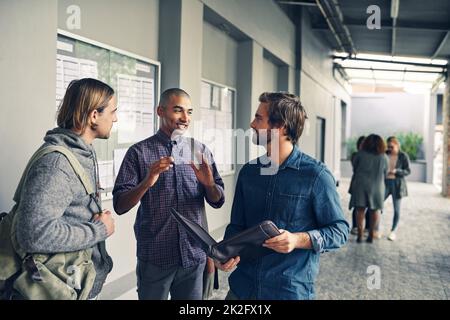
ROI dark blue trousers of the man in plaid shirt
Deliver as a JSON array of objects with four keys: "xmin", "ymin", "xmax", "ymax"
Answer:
[{"xmin": 136, "ymin": 259, "xmax": 205, "ymax": 300}]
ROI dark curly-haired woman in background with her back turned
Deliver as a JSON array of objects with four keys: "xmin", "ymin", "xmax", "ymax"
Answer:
[{"xmin": 350, "ymin": 134, "xmax": 388, "ymax": 242}]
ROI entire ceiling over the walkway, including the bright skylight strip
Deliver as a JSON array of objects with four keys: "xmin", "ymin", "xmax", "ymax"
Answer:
[{"xmin": 277, "ymin": 0, "xmax": 450, "ymax": 88}]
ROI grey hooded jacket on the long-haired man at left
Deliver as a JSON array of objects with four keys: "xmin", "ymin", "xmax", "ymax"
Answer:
[{"xmin": 16, "ymin": 128, "xmax": 112, "ymax": 298}]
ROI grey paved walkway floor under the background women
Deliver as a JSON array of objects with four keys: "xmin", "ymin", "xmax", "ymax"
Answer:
[{"xmin": 213, "ymin": 180, "xmax": 450, "ymax": 300}]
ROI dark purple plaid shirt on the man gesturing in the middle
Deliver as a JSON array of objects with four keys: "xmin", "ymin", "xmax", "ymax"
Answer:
[{"xmin": 113, "ymin": 130, "xmax": 225, "ymax": 268}]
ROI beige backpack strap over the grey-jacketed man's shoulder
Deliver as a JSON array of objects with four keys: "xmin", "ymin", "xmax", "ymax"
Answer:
[{"xmin": 13, "ymin": 145, "xmax": 95, "ymax": 203}]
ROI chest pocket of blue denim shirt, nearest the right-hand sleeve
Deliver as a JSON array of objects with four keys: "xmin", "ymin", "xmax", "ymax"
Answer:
[{"xmin": 275, "ymin": 192, "xmax": 310, "ymax": 231}]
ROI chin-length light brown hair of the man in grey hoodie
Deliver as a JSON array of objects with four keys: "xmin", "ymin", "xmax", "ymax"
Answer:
[{"xmin": 57, "ymin": 78, "xmax": 114, "ymax": 133}]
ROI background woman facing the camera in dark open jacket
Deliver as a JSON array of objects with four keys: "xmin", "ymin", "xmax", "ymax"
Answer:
[{"xmin": 385, "ymin": 137, "xmax": 411, "ymax": 241}]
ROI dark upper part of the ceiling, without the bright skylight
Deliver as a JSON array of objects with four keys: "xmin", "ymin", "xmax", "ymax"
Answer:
[{"xmin": 277, "ymin": 0, "xmax": 450, "ymax": 59}]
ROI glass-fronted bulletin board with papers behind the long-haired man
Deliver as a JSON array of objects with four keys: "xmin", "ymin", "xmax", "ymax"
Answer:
[{"xmin": 56, "ymin": 30, "xmax": 161, "ymax": 197}]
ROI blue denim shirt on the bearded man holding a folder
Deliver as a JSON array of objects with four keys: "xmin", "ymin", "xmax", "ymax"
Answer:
[{"xmin": 224, "ymin": 147, "xmax": 349, "ymax": 300}]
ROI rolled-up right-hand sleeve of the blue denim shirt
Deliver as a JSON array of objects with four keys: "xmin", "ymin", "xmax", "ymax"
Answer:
[{"xmin": 307, "ymin": 168, "xmax": 349, "ymax": 253}]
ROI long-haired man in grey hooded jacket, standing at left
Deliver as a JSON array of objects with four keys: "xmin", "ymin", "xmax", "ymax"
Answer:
[{"xmin": 16, "ymin": 79, "xmax": 117, "ymax": 299}]
